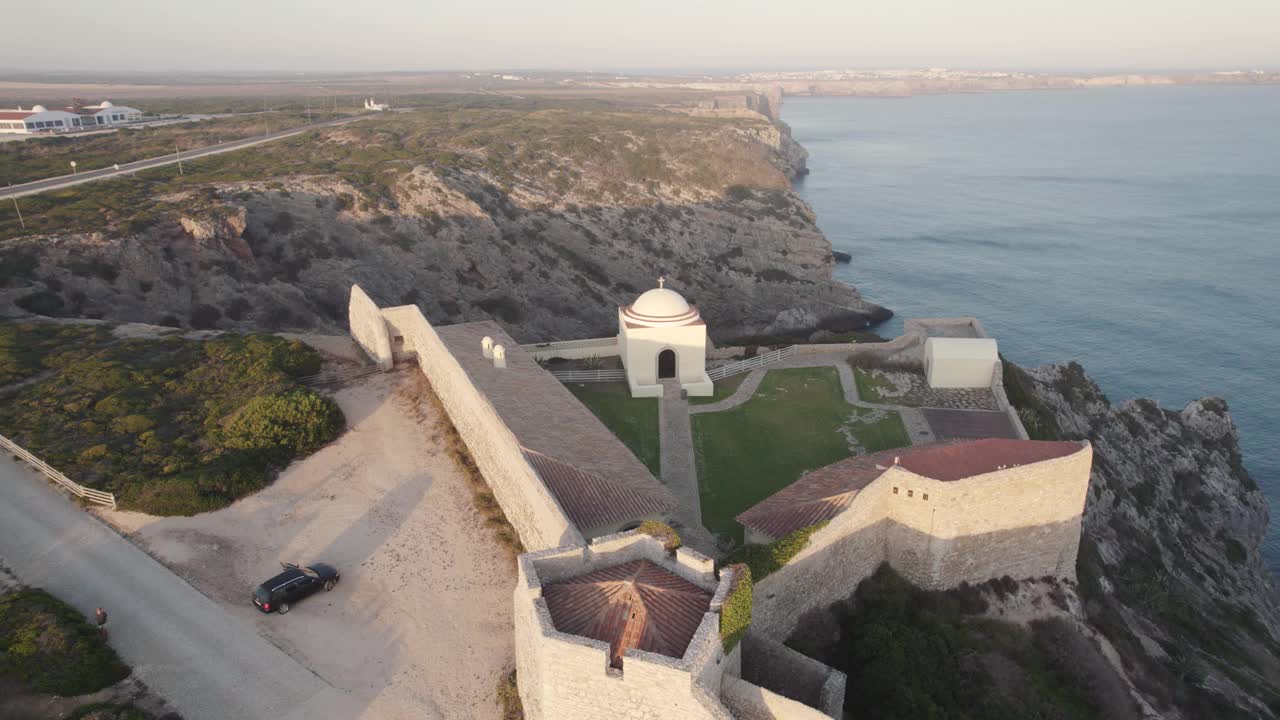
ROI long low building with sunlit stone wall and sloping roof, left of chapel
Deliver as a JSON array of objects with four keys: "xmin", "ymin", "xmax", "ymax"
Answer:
[{"xmin": 351, "ymin": 287, "xmax": 676, "ymax": 550}]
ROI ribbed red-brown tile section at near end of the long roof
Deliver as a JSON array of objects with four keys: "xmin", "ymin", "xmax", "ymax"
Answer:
[{"xmin": 521, "ymin": 447, "xmax": 676, "ymax": 529}]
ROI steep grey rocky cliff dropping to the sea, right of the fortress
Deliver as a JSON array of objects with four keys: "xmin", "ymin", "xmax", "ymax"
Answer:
[{"xmin": 1015, "ymin": 364, "xmax": 1280, "ymax": 719}]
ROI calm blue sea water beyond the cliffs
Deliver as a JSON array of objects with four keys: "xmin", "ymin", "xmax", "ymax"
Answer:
[{"xmin": 783, "ymin": 87, "xmax": 1280, "ymax": 570}]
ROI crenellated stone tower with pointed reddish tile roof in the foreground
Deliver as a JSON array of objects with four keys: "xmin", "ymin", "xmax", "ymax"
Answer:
[{"xmin": 513, "ymin": 532, "xmax": 845, "ymax": 720}]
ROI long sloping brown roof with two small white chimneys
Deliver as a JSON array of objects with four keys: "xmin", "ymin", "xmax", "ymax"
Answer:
[{"xmin": 435, "ymin": 320, "xmax": 676, "ymax": 530}]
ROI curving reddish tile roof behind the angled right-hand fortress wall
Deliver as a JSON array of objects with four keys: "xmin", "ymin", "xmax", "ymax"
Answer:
[{"xmin": 737, "ymin": 430, "xmax": 1082, "ymax": 538}]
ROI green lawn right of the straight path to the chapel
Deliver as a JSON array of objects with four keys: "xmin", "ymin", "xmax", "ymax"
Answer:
[{"xmin": 692, "ymin": 368, "xmax": 910, "ymax": 542}]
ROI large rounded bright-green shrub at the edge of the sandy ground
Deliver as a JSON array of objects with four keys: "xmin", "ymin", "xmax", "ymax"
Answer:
[{"xmin": 227, "ymin": 389, "xmax": 343, "ymax": 455}]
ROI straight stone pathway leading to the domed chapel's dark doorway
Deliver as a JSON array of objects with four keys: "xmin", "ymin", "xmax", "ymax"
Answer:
[{"xmin": 658, "ymin": 379, "xmax": 721, "ymax": 557}]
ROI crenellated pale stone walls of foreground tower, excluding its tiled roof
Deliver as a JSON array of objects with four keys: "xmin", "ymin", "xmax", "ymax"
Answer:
[{"xmin": 513, "ymin": 532, "xmax": 845, "ymax": 720}]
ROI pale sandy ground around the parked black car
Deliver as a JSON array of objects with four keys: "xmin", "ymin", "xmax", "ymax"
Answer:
[{"xmin": 102, "ymin": 370, "xmax": 515, "ymax": 719}]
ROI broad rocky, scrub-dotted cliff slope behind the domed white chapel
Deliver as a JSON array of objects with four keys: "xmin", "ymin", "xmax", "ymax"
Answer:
[{"xmin": 0, "ymin": 105, "xmax": 888, "ymax": 341}]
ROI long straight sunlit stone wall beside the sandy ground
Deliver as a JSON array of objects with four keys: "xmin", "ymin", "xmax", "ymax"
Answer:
[{"xmin": 349, "ymin": 286, "xmax": 584, "ymax": 550}]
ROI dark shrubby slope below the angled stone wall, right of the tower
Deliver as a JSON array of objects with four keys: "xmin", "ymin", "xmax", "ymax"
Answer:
[{"xmin": 788, "ymin": 565, "xmax": 1139, "ymax": 720}]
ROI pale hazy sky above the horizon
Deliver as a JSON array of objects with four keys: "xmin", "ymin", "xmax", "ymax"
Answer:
[{"xmin": 0, "ymin": 0, "xmax": 1280, "ymax": 72}]
